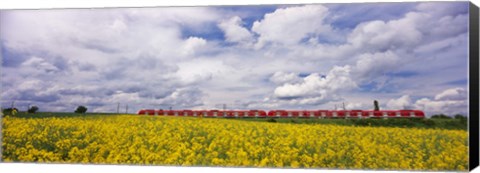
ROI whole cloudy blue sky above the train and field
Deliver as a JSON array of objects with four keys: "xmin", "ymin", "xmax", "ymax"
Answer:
[{"xmin": 0, "ymin": 2, "xmax": 468, "ymax": 115}]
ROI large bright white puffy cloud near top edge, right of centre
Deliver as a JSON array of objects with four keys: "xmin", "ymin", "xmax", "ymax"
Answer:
[{"xmin": 252, "ymin": 5, "xmax": 331, "ymax": 48}]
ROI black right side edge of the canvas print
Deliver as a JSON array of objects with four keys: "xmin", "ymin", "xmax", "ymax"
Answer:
[{"xmin": 468, "ymin": 2, "xmax": 480, "ymax": 171}]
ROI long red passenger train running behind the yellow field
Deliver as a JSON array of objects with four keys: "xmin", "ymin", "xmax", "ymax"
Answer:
[{"xmin": 138, "ymin": 109, "xmax": 425, "ymax": 118}]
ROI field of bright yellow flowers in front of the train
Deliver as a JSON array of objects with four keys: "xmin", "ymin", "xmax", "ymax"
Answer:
[{"xmin": 2, "ymin": 115, "xmax": 468, "ymax": 171}]
